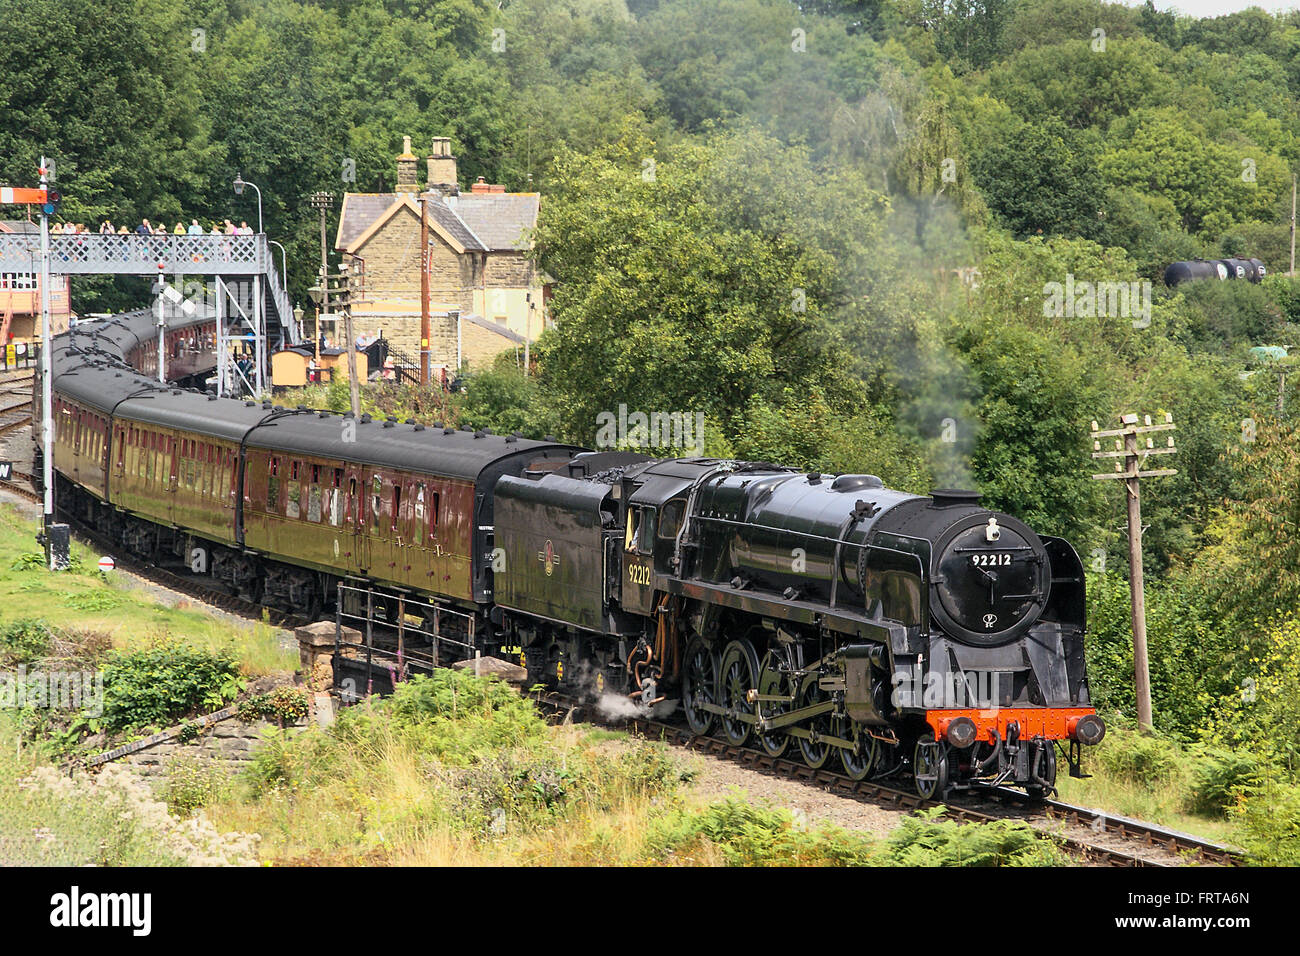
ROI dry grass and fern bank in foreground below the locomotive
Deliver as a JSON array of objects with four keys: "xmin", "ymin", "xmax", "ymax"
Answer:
[{"xmin": 187, "ymin": 671, "xmax": 1066, "ymax": 866}]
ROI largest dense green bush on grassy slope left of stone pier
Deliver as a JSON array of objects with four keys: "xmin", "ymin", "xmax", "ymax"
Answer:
[{"xmin": 96, "ymin": 644, "xmax": 243, "ymax": 734}]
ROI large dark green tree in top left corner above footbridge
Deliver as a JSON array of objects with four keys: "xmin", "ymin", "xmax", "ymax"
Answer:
[{"xmin": 0, "ymin": 0, "xmax": 218, "ymax": 222}]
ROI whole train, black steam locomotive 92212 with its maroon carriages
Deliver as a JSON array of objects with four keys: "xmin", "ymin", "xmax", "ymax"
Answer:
[{"xmin": 35, "ymin": 312, "xmax": 1105, "ymax": 797}]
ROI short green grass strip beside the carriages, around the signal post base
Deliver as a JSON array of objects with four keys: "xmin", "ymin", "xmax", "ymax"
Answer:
[{"xmin": 0, "ymin": 503, "xmax": 298, "ymax": 676}]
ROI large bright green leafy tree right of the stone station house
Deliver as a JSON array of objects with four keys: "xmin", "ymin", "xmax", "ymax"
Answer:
[{"xmin": 527, "ymin": 130, "xmax": 884, "ymax": 450}]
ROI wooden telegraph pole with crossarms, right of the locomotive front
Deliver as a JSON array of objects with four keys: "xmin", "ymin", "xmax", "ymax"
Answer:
[{"xmin": 1092, "ymin": 412, "xmax": 1178, "ymax": 730}]
